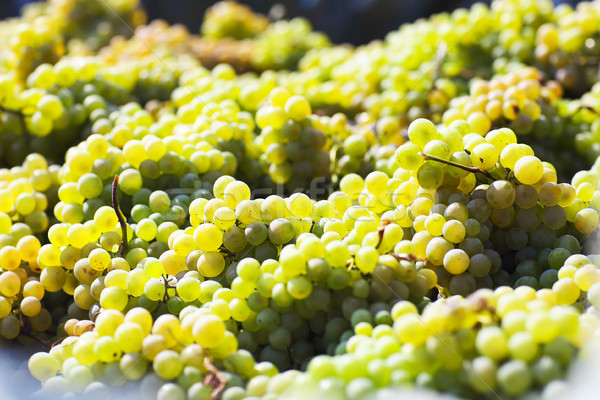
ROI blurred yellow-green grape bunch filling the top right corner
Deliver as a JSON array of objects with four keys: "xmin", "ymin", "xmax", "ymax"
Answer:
[{"xmin": 434, "ymin": 0, "xmax": 600, "ymax": 96}]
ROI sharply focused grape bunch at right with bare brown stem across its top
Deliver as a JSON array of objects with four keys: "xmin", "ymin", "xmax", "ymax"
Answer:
[{"xmin": 394, "ymin": 120, "xmax": 598, "ymax": 295}]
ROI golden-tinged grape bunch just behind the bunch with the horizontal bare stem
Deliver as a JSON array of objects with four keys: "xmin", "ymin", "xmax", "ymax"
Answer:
[{"xmin": 443, "ymin": 67, "xmax": 586, "ymax": 181}]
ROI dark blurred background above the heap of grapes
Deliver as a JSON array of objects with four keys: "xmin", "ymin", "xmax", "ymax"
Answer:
[{"xmin": 0, "ymin": 0, "xmax": 579, "ymax": 44}]
